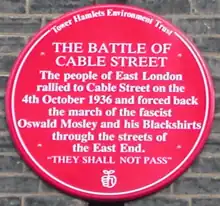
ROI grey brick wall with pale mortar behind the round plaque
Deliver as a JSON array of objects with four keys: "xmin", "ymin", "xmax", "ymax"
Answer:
[{"xmin": 0, "ymin": 0, "xmax": 220, "ymax": 206}]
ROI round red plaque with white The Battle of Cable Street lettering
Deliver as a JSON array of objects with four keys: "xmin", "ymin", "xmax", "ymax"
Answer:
[{"xmin": 6, "ymin": 5, "xmax": 214, "ymax": 200}]
